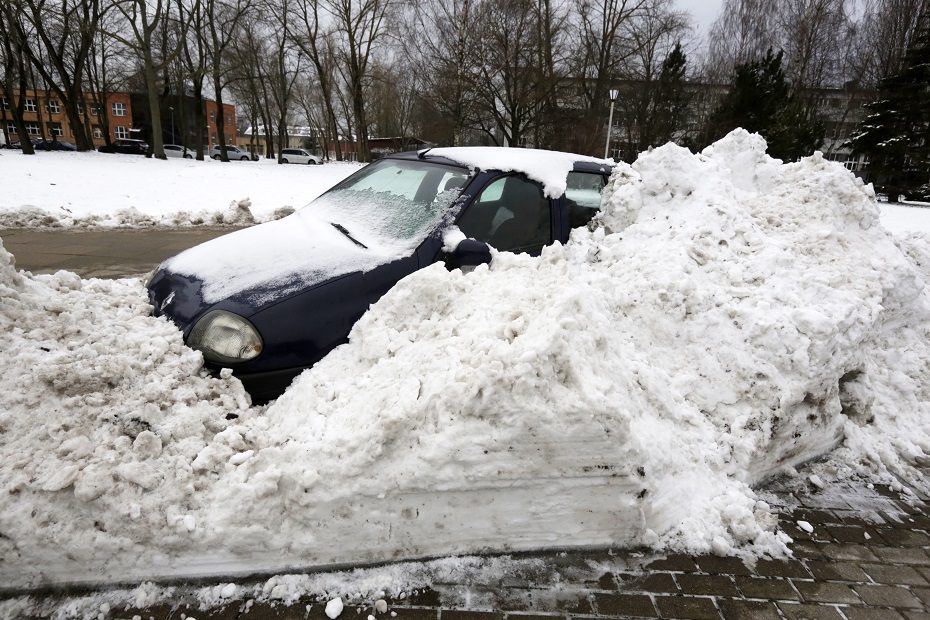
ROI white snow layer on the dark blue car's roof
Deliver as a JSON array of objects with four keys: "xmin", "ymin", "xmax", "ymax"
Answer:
[{"xmin": 420, "ymin": 146, "xmax": 616, "ymax": 198}]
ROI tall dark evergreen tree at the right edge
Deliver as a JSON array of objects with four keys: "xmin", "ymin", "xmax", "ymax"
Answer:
[{"xmin": 847, "ymin": 10, "xmax": 930, "ymax": 202}]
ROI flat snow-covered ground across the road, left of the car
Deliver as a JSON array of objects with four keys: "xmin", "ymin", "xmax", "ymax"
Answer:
[{"xmin": 0, "ymin": 150, "xmax": 359, "ymax": 228}]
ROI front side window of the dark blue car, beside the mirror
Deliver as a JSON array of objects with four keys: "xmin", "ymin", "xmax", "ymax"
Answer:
[{"xmin": 458, "ymin": 175, "xmax": 552, "ymax": 253}]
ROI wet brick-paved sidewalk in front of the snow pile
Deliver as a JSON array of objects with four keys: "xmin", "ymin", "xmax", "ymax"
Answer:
[{"xmin": 7, "ymin": 472, "xmax": 930, "ymax": 620}]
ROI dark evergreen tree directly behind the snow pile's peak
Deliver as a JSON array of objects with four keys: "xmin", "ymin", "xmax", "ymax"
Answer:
[{"xmin": 706, "ymin": 49, "xmax": 824, "ymax": 160}]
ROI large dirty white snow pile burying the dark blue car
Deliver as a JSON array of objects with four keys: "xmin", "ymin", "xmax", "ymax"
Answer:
[{"xmin": 0, "ymin": 131, "xmax": 930, "ymax": 583}]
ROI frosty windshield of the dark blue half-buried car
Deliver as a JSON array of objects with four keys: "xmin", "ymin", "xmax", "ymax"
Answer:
[{"xmin": 301, "ymin": 159, "xmax": 469, "ymax": 246}]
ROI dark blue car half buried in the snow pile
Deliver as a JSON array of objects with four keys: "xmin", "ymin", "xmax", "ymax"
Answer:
[{"xmin": 147, "ymin": 147, "xmax": 611, "ymax": 402}]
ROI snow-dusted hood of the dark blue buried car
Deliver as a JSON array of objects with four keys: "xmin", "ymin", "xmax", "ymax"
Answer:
[{"xmin": 161, "ymin": 209, "xmax": 415, "ymax": 307}]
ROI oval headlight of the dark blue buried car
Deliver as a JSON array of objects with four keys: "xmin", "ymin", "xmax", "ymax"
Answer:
[{"xmin": 187, "ymin": 310, "xmax": 262, "ymax": 364}]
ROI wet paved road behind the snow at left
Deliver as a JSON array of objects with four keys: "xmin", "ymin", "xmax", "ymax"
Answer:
[{"xmin": 0, "ymin": 227, "xmax": 234, "ymax": 278}]
